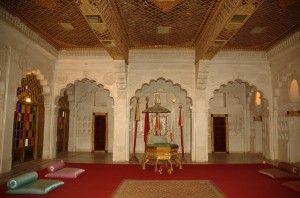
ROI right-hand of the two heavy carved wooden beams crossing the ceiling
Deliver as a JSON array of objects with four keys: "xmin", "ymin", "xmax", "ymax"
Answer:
[{"xmin": 195, "ymin": 0, "xmax": 264, "ymax": 63}]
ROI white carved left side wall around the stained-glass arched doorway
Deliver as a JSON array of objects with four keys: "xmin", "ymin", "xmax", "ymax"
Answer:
[{"xmin": 0, "ymin": 15, "xmax": 56, "ymax": 173}]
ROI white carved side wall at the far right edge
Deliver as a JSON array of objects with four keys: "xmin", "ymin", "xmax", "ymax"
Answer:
[{"xmin": 268, "ymin": 31, "xmax": 300, "ymax": 162}]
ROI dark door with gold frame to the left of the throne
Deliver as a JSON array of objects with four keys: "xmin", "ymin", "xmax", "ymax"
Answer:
[{"xmin": 92, "ymin": 113, "xmax": 108, "ymax": 152}]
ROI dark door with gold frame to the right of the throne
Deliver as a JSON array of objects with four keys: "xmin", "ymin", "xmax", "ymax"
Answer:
[{"xmin": 210, "ymin": 114, "xmax": 229, "ymax": 153}]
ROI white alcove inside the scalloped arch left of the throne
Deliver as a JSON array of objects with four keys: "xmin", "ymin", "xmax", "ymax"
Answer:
[{"xmin": 57, "ymin": 79, "xmax": 114, "ymax": 152}]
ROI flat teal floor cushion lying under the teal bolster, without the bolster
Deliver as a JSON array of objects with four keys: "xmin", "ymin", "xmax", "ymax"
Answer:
[{"xmin": 6, "ymin": 179, "xmax": 64, "ymax": 195}]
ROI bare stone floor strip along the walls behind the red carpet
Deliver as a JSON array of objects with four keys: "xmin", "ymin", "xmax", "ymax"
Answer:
[{"xmin": 0, "ymin": 152, "xmax": 275, "ymax": 184}]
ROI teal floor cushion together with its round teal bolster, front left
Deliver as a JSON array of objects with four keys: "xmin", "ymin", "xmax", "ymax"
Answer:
[{"xmin": 6, "ymin": 171, "xmax": 64, "ymax": 194}]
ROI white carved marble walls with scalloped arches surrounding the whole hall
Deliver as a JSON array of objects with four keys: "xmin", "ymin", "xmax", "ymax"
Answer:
[{"xmin": 0, "ymin": 5, "xmax": 300, "ymax": 173}]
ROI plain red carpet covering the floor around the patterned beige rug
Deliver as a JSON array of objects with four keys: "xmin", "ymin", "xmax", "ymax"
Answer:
[{"xmin": 0, "ymin": 163, "xmax": 300, "ymax": 198}]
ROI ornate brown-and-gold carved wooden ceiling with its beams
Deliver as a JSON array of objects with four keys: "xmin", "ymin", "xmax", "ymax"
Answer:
[{"xmin": 0, "ymin": 0, "xmax": 300, "ymax": 62}]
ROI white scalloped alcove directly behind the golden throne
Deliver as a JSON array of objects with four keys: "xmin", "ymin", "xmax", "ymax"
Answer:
[{"xmin": 130, "ymin": 78, "xmax": 192, "ymax": 156}]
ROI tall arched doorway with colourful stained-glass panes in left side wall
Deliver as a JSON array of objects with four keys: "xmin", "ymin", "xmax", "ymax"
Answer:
[{"xmin": 12, "ymin": 73, "xmax": 45, "ymax": 165}]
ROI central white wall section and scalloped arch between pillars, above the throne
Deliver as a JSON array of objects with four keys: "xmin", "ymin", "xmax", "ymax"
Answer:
[{"xmin": 127, "ymin": 50, "xmax": 195, "ymax": 156}]
